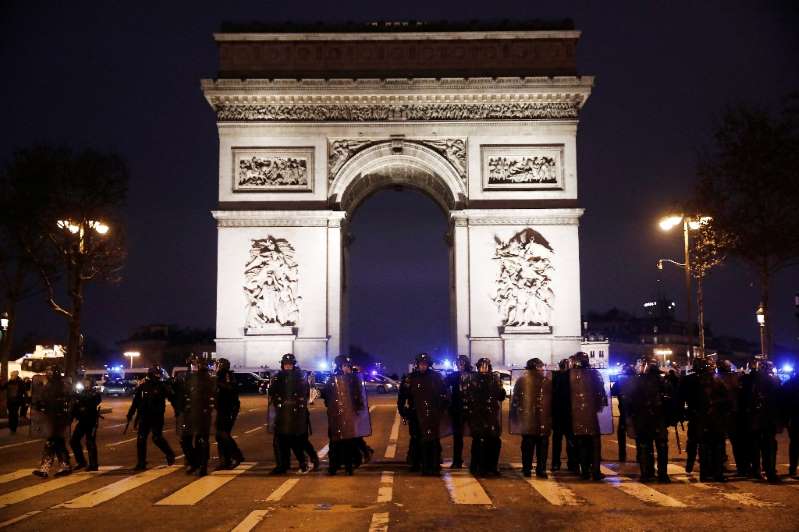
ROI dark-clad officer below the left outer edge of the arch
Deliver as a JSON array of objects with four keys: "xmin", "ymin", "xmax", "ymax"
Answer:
[{"xmin": 216, "ymin": 358, "xmax": 244, "ymax": 469}]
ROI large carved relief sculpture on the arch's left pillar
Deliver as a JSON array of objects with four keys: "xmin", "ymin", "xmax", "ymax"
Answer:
[{"xmin": 244, "ymin": 236, "xmax": 300, "ymax": 329}]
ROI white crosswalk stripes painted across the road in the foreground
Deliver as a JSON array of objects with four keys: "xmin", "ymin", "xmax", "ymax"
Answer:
[{"xmin": 0, "ymin": 460, "xmax": 786, "ymax": 532}]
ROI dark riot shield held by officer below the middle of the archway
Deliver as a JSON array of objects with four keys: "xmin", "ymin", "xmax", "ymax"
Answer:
[{"xmin": 410, "ymin": 370, "xmax": 452, "ymax": 440}]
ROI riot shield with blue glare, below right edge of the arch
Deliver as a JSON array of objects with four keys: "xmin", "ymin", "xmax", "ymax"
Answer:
[{"xmin": 569, "ymin": 368, "xmax": 613, "ymax": 436}]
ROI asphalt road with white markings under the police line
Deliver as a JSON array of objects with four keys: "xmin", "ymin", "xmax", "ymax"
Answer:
[{"xmin": 0, "ymin": 395, "xmax": 799, "ymax": 532}]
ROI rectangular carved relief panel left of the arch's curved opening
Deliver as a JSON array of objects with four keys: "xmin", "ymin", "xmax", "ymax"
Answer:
[{"xmin": 233, "ymin": 147, "xmax": 314, "ymax": 192}]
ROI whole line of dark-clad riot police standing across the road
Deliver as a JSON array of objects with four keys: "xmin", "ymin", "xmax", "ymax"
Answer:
[{"xmin": 5, "ymin": 353, "xmax": 799, "ymax": 482}]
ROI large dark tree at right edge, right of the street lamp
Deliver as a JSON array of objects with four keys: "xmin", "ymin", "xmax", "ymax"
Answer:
[{"xmin": 696, "ymin": 95, "xmax": 799, "ymax": 356}]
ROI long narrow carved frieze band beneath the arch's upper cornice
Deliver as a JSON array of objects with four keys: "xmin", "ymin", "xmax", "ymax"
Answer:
[{"xmin": 216, "ymin": 101, "xmax": 580, "ymax": 122}]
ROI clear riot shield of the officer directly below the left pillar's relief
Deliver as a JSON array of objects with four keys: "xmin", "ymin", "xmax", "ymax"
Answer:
[{"xmin": 266, "ymin": 371, "xmax": 309, "ymax": 435}]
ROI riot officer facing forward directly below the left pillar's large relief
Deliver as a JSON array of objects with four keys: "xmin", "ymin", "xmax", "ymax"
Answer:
[{"xmin": 267, "ymin": 353, "xmax": 310, "ymax": 475}]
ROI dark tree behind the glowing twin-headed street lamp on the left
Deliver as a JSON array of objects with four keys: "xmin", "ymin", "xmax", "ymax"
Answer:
[{"xmin": 7, "ymin": 146, "xmax": 128, "ymax": 375}]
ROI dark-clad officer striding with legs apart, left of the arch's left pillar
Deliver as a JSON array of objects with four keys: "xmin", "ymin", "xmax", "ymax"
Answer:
[{"xmin": 127, "ymin": 364, "xmax": 175, "ymax": 471}]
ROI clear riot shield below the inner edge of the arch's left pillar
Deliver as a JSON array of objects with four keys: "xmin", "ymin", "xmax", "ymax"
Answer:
[{"xmin": 325, "ymin": 374, "xmax": 372, "ymax": 441}]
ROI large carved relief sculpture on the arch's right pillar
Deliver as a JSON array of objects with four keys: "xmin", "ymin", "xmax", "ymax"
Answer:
[{"xmin": 492, "ymin": 228, "xmax": 555, "ymax": 327}]
